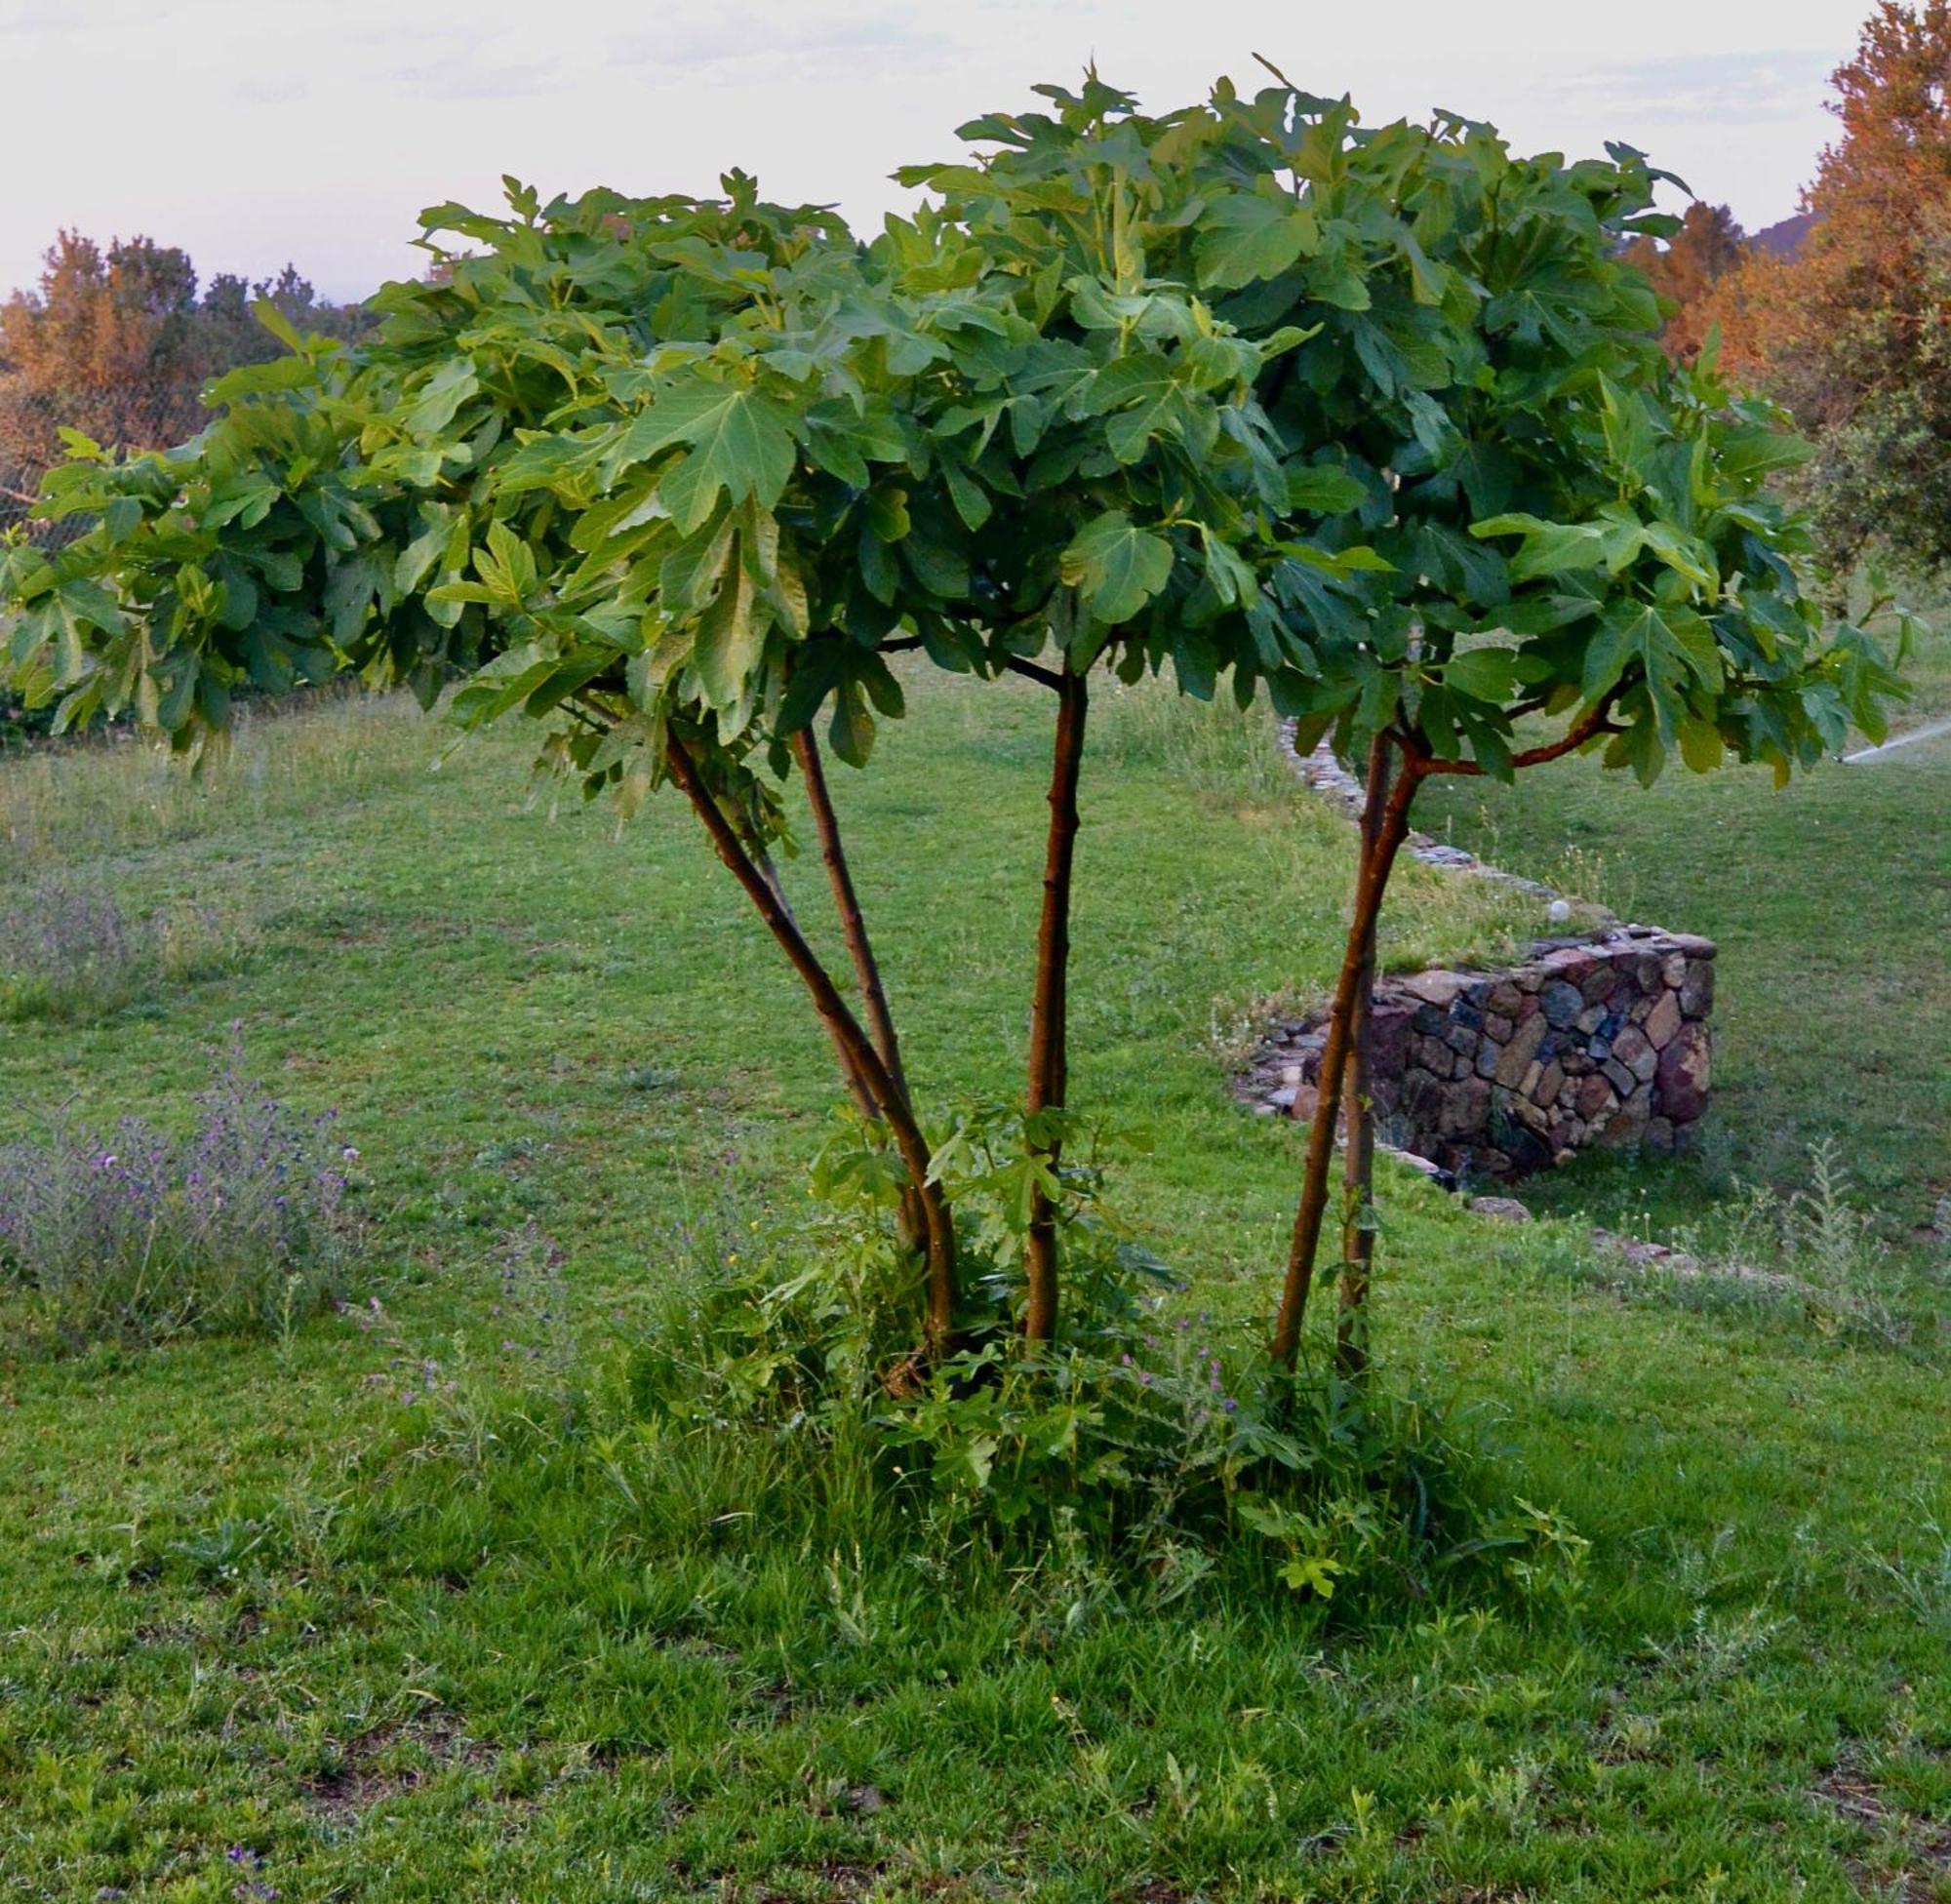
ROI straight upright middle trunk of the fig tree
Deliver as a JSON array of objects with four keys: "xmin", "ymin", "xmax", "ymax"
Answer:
[{"xmin": 1022, "ymin": 673, "xmax": 1089, "ymax": 1342}]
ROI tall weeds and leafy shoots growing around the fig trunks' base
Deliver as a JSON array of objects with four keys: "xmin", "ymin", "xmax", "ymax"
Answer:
[{"xmin": 373, "ymin": 1106, "xmax": 1584, "ymax": 1623}]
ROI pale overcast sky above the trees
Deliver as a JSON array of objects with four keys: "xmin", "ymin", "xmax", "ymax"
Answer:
[{"xmin": 0, "ymin": 0, "xmax": 1869, "ymax": 298}]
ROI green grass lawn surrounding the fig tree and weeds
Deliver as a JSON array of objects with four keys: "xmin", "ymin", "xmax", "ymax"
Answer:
[{"xmin": 0, "ymin": 683, "xmax": 1951, "ymax": 1904}]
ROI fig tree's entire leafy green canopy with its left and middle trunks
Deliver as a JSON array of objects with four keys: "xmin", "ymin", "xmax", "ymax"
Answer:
[{"xmin": 0, "ymin": 74, "xmax": 1892, "ymax": 1344}]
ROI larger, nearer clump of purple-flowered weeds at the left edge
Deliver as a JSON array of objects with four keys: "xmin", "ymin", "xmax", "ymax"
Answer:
[{"xmin": 0, "ymin": 1046, "xmax": 355, "ymax": 1350}]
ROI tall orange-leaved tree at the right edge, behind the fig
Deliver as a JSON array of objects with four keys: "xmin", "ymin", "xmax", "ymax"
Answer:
[{"xmin": 1699, "ymin": 0, "xmax": 1951, "ymax": 568}]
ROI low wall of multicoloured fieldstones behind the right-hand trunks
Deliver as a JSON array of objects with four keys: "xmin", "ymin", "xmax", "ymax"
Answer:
[{"xmin": 1243, "ymin": 925, "xmax": 1715, "ymax": 1176}]
